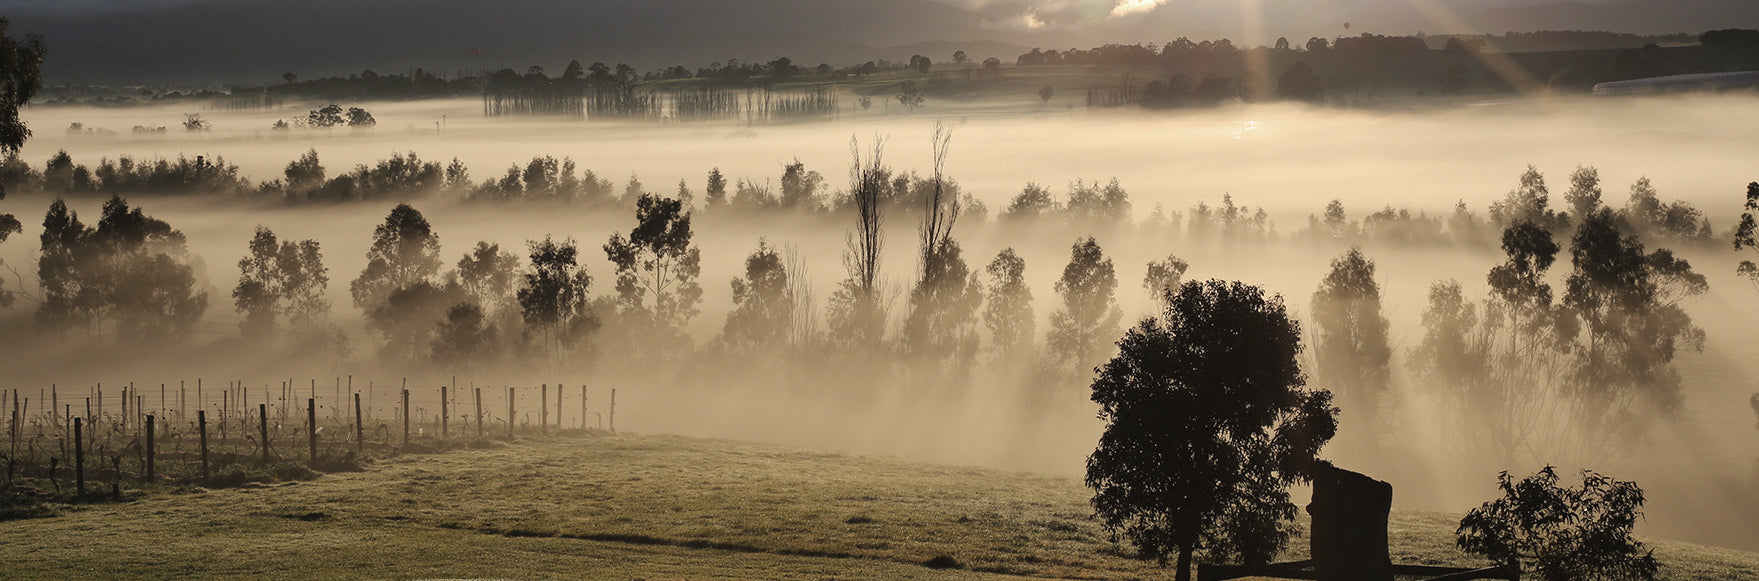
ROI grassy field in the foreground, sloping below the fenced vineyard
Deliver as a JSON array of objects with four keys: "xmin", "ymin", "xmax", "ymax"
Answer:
[{"xmin": 0, "ymin": 435, "xmax": 1759, "ymax": 579}]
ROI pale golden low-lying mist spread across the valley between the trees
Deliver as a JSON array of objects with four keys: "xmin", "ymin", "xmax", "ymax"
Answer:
[{"xmin": 0, "ymin": 95, "xmax": 1759, "ymax": 549}]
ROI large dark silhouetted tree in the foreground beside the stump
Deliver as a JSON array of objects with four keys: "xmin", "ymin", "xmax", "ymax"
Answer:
[{"xmin": 1087, "ymin": 280, "xmax": 1337, "ymax": 581}]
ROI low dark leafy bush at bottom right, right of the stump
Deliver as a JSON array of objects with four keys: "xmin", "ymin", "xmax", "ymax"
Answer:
[{"xmin": 1455, "ymin": 467, "xmax": 1660, "ymax": 581}]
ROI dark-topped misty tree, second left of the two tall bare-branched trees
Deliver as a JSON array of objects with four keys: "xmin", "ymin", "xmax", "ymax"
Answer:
[{"xmin": 605, "ymin": 194, "xmax": 702, "ymax": 331}]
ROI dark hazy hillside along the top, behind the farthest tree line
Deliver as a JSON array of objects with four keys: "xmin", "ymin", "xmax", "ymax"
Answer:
[{"xmin": 0, "ymin": 0, "xmax": 1759, "ymax": 86}]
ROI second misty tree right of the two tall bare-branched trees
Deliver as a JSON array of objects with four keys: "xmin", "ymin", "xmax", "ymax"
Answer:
[{"xmin": 1045, "ymin": 236, "xmax": 1124, "ymax": 373}]
